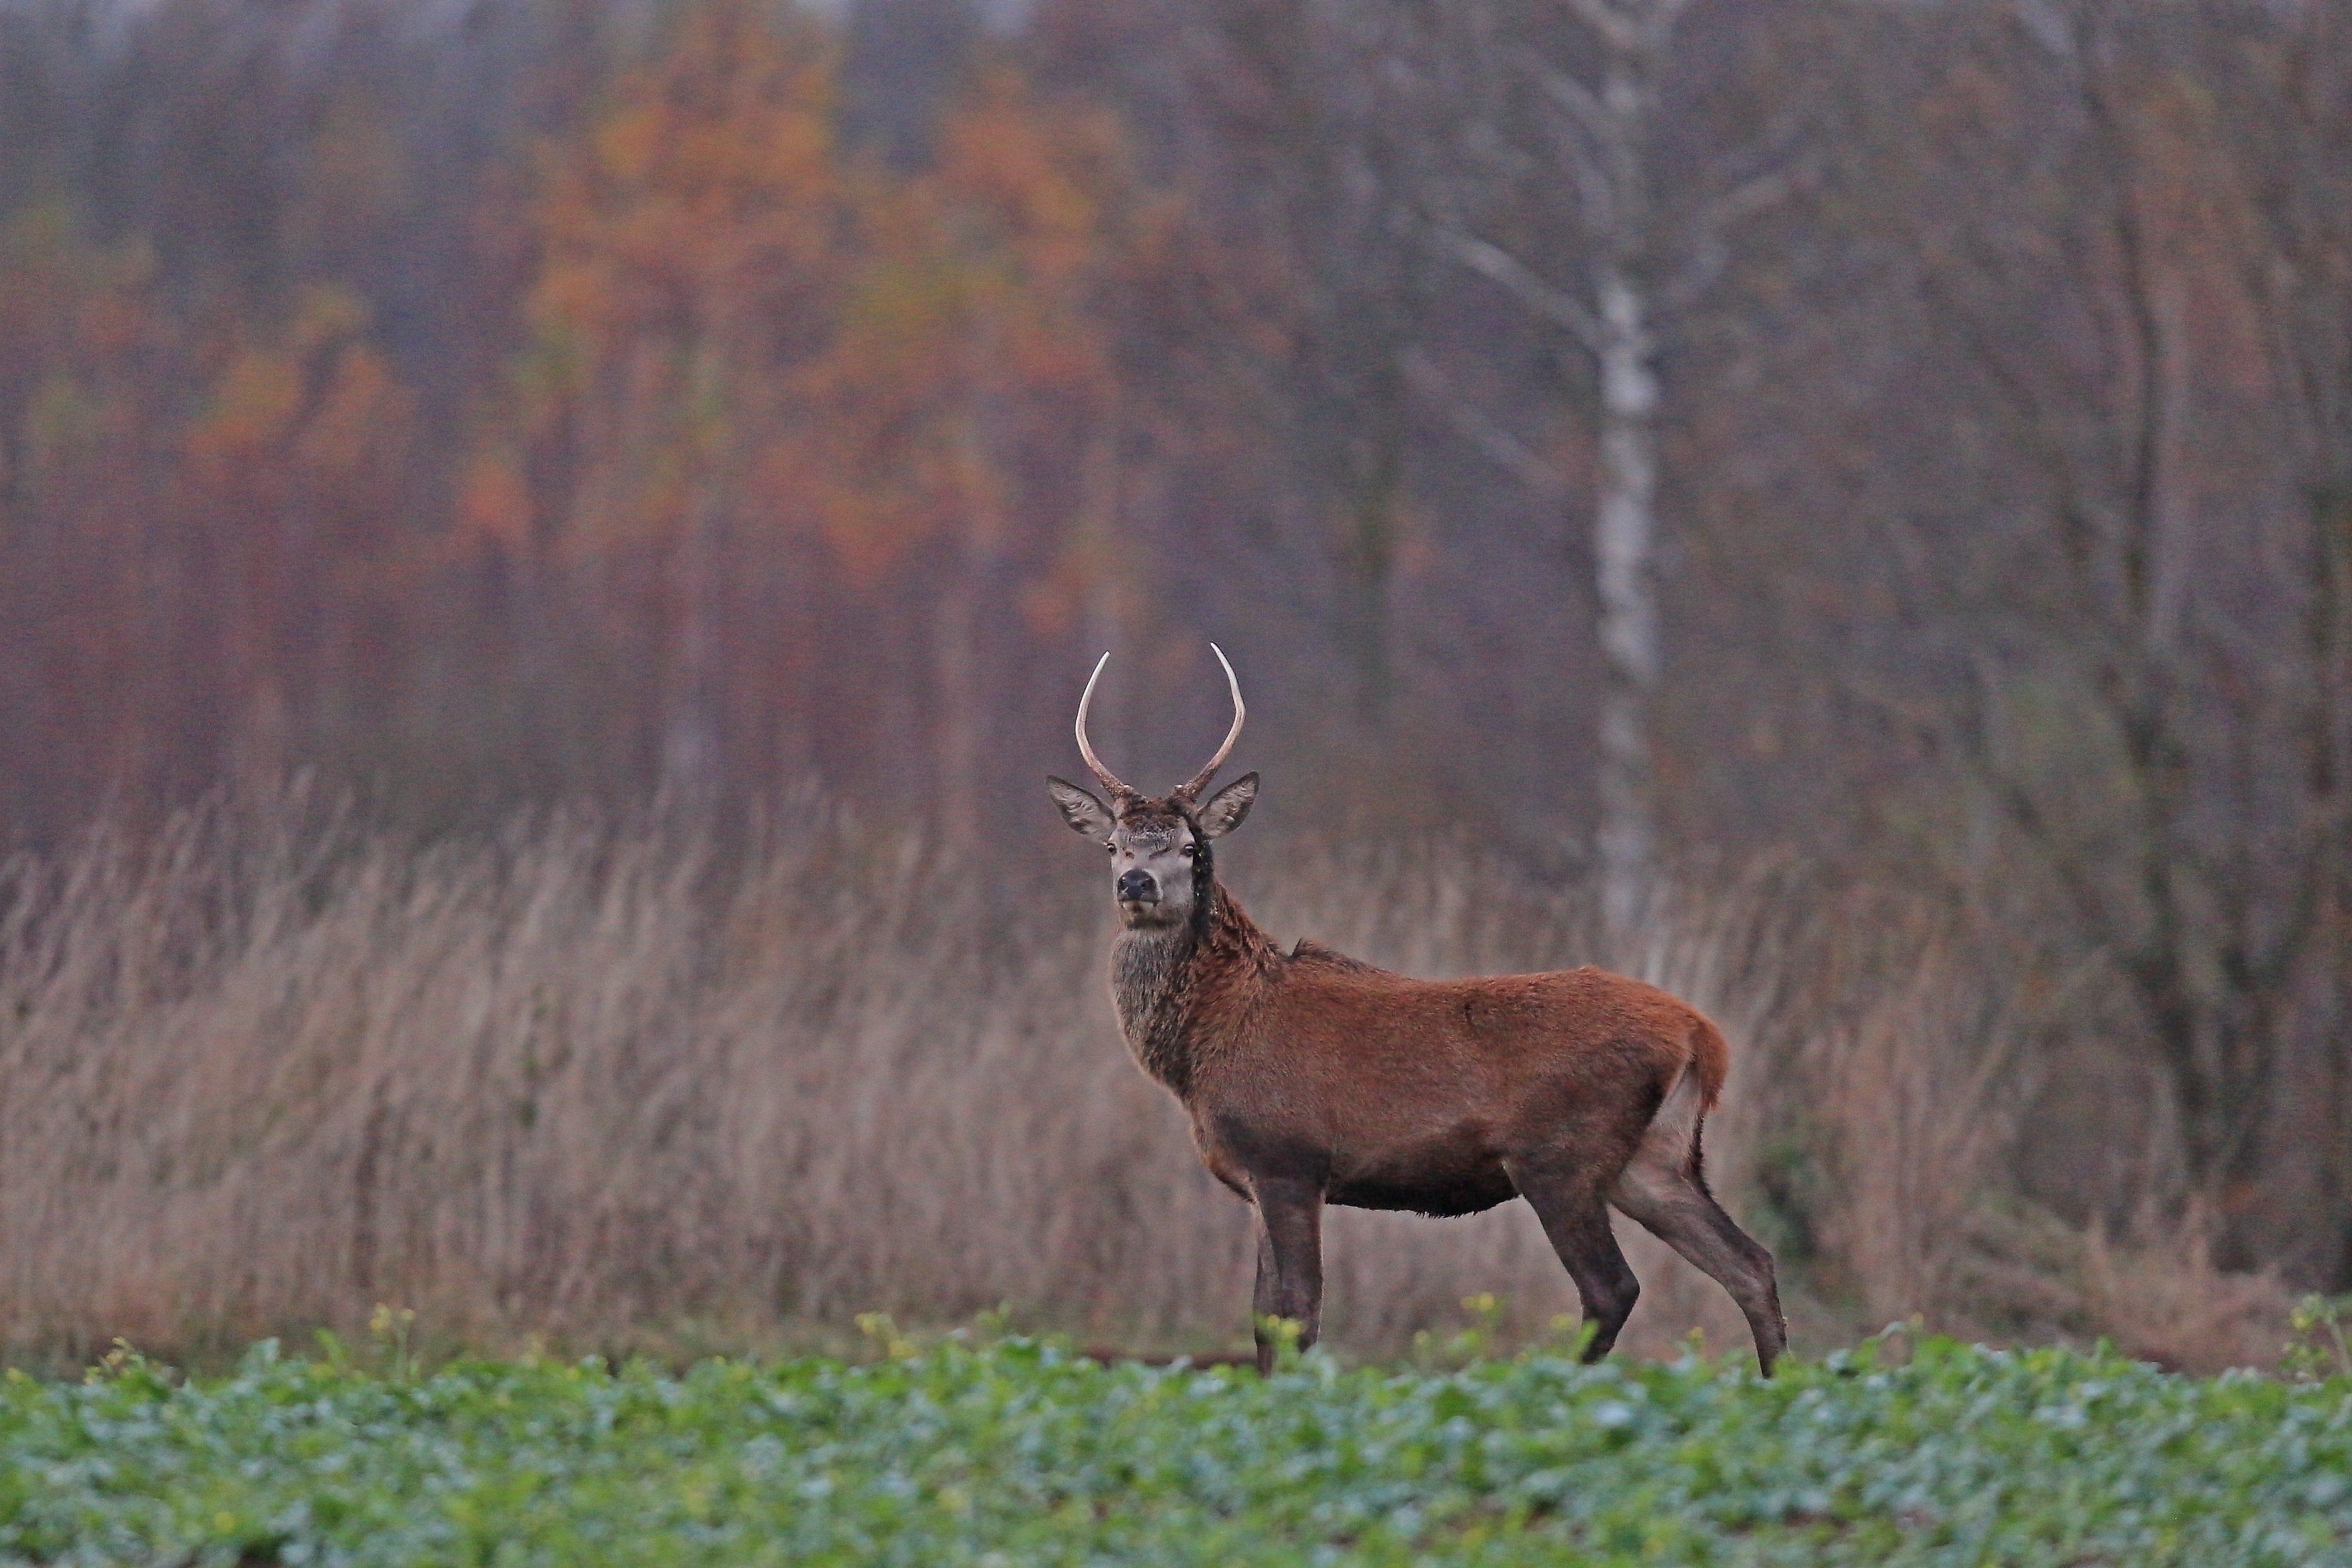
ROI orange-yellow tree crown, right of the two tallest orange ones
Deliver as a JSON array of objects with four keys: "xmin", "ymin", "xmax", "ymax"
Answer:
[{"xmin": 802, "ymin": 73, "xmax": 1134, "ymax": 576}]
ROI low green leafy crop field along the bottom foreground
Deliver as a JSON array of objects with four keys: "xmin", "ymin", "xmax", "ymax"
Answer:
[{"xmin": 0, "ymin": 1340, "xmax": 2352, "ymax": 1565}]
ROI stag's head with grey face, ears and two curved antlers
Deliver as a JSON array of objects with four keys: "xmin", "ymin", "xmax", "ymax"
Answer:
[{"xmin": 1044, "ymin": 642, "xmax": 1259, "ymax": 931}]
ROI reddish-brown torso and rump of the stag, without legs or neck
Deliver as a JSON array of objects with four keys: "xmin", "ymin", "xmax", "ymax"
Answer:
[{"xmin": 1190, "ymin": 943, "xmax": 1726, "ymax": 1215}]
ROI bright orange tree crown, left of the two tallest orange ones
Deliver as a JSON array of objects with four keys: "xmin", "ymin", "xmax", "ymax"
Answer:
[{"xmin": 508, "ymin": 0, "xmax": 842, "ymax": 555}]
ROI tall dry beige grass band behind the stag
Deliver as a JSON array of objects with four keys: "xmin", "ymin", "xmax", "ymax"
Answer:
[{"xmin": 0, "ymin": 792, "xmax": 2269, "ymax": 1359}]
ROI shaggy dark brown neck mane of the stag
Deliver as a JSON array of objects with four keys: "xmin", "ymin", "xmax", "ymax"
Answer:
[{"xmin": 1110, "ymin": 879, "xmax": 1282, "ymax": 1098}]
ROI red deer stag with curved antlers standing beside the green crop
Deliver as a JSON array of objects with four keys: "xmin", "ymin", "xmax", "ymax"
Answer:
[{"xmin": 1047, "ymin": 644, "xmax": 1787, "ymax": 1375}]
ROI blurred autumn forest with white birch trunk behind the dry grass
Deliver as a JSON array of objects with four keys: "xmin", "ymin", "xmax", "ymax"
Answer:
[{"xmin": 0, "ymin": 0, "xmax": 2352, "ymax": 1288}]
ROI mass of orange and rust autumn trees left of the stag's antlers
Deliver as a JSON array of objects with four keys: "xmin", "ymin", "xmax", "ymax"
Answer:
[{"xmin": 0, "ymin": 0, "xmax": 1194, "ymax": 837}]
